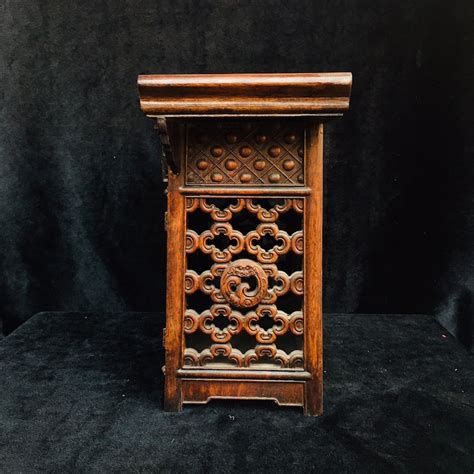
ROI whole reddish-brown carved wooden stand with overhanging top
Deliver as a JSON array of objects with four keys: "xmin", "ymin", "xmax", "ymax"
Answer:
[{"xmin": 138, "ymin": 73, "xmax": 352, "ymax": 415}]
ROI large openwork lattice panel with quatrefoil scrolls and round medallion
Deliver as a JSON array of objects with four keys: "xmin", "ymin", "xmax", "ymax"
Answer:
[{"xmin": 183, "ymin": 197, "xmax": 304, "ymax": 370}]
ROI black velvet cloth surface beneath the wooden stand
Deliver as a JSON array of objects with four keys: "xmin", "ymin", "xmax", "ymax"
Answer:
[{"xmin": 0, "ymin": 313, "xmax": 474, "ymax": 474}]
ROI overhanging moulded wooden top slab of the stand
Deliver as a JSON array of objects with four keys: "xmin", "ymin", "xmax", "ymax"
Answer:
[{"xmin": 138, "ymin": 73, "xmax": 352, "ymax": 116}]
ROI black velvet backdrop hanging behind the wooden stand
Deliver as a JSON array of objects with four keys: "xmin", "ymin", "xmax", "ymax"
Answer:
[{"xmin": 0, "ymin": 0, "xmax": 474, "ymax": 341}]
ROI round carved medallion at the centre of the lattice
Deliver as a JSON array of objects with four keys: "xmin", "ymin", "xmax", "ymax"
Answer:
[{"xmin": 221, "ymin": 258, "xmax": 268, "ymax": 308}]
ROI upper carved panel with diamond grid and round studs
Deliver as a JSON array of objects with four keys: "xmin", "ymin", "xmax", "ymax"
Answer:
[{"xmin": 186, "ymin": 120, "xmax": 304, "ymax": 186}]
